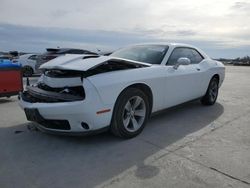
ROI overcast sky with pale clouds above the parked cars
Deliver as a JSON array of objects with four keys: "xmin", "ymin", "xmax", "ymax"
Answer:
[{"xmin": 0, "ymin": 0, "xmax": 250, "ymax": 58}]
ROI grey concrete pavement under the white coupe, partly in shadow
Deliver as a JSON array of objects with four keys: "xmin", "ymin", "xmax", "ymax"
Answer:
[{"xmin": 0, "ymin": 66, "xmax": 250, "ymax": 188}]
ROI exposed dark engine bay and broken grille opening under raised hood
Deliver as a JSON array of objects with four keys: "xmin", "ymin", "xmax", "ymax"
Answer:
[{"xmin": 21, "ymin": 60, "xmax": 147, "ymax": 103}]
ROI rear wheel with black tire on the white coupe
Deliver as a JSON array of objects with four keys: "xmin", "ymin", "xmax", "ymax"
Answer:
[{"xmin": 201, "ymin": 77, "xmax": 219, "ymax": 105}]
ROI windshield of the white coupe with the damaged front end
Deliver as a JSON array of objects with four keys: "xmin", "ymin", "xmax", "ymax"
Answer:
[{"xmin": 110, "ymin": 45, "xmax": 168, "ymax": 64}]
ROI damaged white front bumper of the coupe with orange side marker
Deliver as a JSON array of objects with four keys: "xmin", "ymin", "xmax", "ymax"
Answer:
[{"xmin": 19, "ymin": 94, "xmax": 112, "ymax": 134}]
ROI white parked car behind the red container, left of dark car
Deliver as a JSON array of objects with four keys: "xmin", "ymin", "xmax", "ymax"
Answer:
[{"xmin": 13, "ymin": 54, "xmax": 38, "ymax": 77}]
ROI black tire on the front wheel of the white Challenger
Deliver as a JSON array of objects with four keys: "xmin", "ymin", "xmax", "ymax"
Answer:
[{"xmin": 110, "ymin": 88, "xmax": 150, "ymax": 138}]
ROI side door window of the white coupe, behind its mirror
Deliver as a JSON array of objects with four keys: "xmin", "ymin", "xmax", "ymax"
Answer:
[{"xmin": 167, "ymin": 47, "xmax": 203, "ymax": 65}]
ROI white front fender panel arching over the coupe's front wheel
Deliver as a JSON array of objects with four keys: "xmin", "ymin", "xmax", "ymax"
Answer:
[{"xmin": 88, "ymin": 68, "xmax": 165, "ymax": 111}]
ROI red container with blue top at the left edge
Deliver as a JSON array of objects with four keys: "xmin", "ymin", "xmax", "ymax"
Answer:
[{"xmin": 0, "ymin": 61, "xmax": 23, "ymax": 97}]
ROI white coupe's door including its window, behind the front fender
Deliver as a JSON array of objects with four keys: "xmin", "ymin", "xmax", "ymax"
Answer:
[{"xmin": 164, "ymin": 47, "xmax": 204, "ymax": 107}]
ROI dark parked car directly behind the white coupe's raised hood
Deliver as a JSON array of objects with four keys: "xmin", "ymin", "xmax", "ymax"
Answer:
[{"xmin": 35, "ymin": 48, "xmax": 97, "ymax": 72}]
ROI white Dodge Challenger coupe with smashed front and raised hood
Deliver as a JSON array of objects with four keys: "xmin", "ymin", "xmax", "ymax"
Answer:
[{"xmin": 20, "ymin": 43, "xmax": 225, "ymax": 138}]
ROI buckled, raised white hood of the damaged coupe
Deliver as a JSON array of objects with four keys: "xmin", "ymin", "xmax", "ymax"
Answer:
[{"xmin": 40, "ymin": 54, "xmax": 150, "ymax": 71}]
